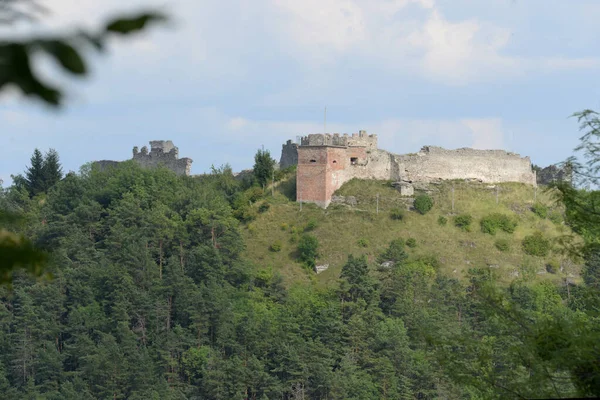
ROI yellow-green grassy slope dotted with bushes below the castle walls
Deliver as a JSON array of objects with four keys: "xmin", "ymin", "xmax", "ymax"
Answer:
[{"xmin": 244, "ymin": 180, "xmax": 579, "ymax": 284}]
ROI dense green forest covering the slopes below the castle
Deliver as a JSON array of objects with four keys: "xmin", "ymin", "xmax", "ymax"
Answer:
[{"xmin": 0, "ymin": 162, "xmax": 600, "ymax": 400}]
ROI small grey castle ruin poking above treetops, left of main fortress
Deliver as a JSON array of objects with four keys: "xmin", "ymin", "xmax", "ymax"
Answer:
[{"xmin": 94, "ymin": 140, "xmax": 193, "ymax": 176}]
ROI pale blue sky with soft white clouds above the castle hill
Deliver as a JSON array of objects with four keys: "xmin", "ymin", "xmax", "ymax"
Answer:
[{"xmin": 0, "ymin": 0, "xmax": 600, "ymax": 186}]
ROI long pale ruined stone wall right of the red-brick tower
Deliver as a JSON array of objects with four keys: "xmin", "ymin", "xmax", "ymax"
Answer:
[{"xmin": 395, "ymin": 146, "xmax": 536, "ymax": 186}]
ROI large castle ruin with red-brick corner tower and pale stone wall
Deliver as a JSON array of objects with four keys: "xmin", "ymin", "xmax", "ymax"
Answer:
[{"xmin": 281, "ymin": 131, "xmax": 536, "ymax": 207}]
